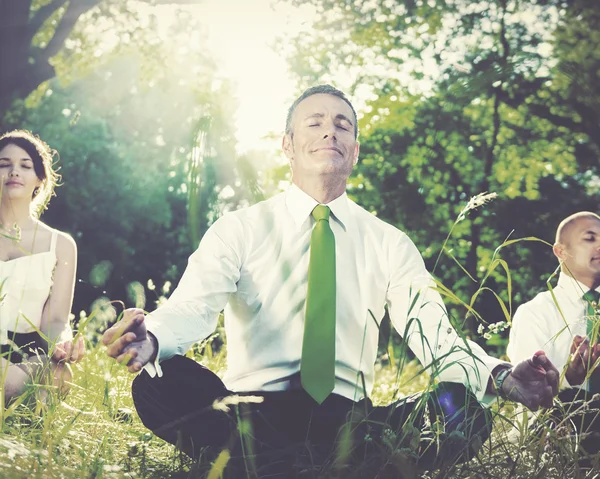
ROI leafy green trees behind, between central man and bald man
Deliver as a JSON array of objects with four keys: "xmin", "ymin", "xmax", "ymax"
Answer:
[{"xmin": 290, "ymin": 0, "xmax": 600, "ymax": 344}]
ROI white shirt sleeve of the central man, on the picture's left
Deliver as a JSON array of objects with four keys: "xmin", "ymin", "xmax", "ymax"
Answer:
[{"xmin": 145, "ymin": 214, "xmax": 244, "ymax": 376}]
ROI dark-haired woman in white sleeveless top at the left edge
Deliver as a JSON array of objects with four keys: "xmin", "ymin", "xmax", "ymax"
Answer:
[{"xmin": 0, "ymin": 130, "xmax": 85, "ymax": 404}]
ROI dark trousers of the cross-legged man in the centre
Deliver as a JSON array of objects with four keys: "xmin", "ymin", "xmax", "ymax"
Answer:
[{"xmin": 132, "ymin": 356, "xmax": 491, "ymax": 477}]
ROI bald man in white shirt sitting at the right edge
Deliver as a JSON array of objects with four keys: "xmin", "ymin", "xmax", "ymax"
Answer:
[{"xmin": 507, "ymin": 211, "xmax": 600, "ymax": 460}]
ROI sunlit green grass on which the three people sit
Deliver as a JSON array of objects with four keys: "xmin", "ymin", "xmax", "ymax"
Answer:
[{"xmin": 0, "ymin": 336, "xmax": 595, "ymax": 479}]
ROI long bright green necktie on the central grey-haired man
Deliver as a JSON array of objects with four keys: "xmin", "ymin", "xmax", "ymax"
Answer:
[{"xmin": 300, "ymin": 205, "xmax": 335, "ymax": 404}]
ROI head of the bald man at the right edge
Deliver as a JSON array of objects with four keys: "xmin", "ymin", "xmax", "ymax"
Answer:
[{"xmin": 554, "ymin": 218, "xmax": 600, "ymax": 283}]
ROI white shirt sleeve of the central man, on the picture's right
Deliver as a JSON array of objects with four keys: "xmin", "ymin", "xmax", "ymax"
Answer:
[{"xmin": 386, "ymin": 235, "xmax": 510, "ymax": 402}]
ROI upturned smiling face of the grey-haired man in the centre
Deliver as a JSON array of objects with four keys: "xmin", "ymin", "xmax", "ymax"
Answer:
[{"xmin": 283, "ymin": 93, "xmax": 359, "ymax": 183}]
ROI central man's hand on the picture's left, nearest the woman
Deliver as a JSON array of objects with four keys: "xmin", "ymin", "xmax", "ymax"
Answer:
[{"xmin": 102, "ymin": 308, "xmax": 158, "ymax": 373}]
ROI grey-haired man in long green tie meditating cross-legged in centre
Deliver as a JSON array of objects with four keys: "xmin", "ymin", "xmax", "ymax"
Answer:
[{"xmin": 103, "ymin": 85, "xmax": 558, "ymax": 473}]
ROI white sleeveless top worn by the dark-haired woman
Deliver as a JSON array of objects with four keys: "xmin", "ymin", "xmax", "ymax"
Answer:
[{"xmin": 0, "ymin": 230, "xmax": 58, "ymax": 343}]
